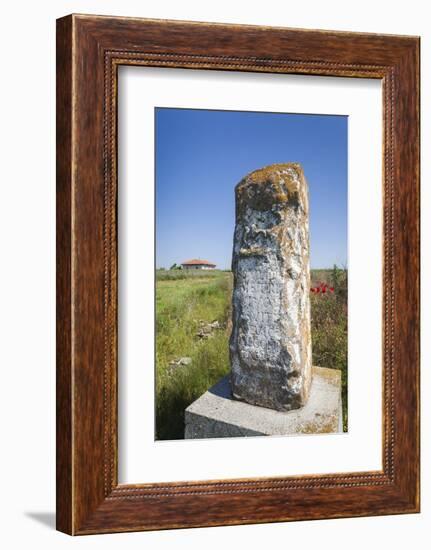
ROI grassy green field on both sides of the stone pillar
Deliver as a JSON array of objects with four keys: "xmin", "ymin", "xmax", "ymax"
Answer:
[{"xmin": 156, "ymin": 269, "xmax": 347, "ymax": 439}]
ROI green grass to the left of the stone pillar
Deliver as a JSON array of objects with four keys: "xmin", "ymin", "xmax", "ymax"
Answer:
[{"xmin": 156, "ymin": 271, "xmax": 232, "ymax": 439}]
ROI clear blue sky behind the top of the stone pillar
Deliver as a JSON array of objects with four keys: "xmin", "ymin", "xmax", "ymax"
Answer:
[{"xmin": 155, "ymin": 108, "xmax": 347, "ymax": 269}]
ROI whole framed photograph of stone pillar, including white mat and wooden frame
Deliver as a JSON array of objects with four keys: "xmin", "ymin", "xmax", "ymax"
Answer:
[{"xmin": 57, "ymin": 15, "xmax": 419, "ymax": 535}]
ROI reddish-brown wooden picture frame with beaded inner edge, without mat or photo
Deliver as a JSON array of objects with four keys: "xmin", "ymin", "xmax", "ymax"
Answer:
[{"xmin": 56, "ymin": 15, "xmax": 420, "ymax": 535}]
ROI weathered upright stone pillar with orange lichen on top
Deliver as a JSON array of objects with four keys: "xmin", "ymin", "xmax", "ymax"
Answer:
[{"xmin": 230, "ymin": 163, "xmax": 312, "ymax": 411}]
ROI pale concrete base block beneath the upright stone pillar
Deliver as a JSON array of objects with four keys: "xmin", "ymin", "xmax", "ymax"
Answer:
[{"xmin": 185, "ymin": 367, "xmax": 343, "ymax": 439}]
